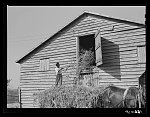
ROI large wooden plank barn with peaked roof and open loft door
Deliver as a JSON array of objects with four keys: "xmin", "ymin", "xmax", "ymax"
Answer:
[{"xmin": 17, "ymin": 12, "xmax": 146, "ymax": 108}]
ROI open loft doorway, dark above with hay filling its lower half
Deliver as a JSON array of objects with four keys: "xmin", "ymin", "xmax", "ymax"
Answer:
[{"xmin": 77, "ymin": 34, "xmax": 96, "ymax": 75}]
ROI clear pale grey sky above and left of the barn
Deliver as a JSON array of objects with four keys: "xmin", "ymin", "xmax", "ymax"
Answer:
[{"xmin": 7, "ymin": 6, "xmax": 146, "ymax": 89}]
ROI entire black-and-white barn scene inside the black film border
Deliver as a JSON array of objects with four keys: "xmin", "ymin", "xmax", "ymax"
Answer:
[{"xmin": 6, "ymin": 5, "xmax": 147, "ymax": 114}]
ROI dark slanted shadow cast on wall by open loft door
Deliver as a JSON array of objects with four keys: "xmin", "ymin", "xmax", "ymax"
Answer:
[{"xmin": 100, "ymin": 37, "xmax": 121, "ymax": 80}]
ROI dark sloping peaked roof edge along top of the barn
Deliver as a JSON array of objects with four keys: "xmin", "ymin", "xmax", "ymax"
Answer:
[{"xmin": 16, "ymin": 11, "xmax": 145, "ymax": 63}]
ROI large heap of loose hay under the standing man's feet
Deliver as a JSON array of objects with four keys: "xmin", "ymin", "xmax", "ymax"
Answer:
[{"xmin": 35, "ymin": 85, "xmax": 103, "ymax": 108}]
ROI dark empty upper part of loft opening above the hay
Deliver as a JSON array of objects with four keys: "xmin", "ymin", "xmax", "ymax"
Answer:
[{"xmin": 79, "ymin": 34, "xmax": 96, "ymax": 66}]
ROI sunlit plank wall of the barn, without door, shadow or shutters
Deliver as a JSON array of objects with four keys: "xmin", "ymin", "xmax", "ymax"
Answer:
[{"xmin": 20, "ymin": 16, "xmax": 145, "ymax": 108}]
